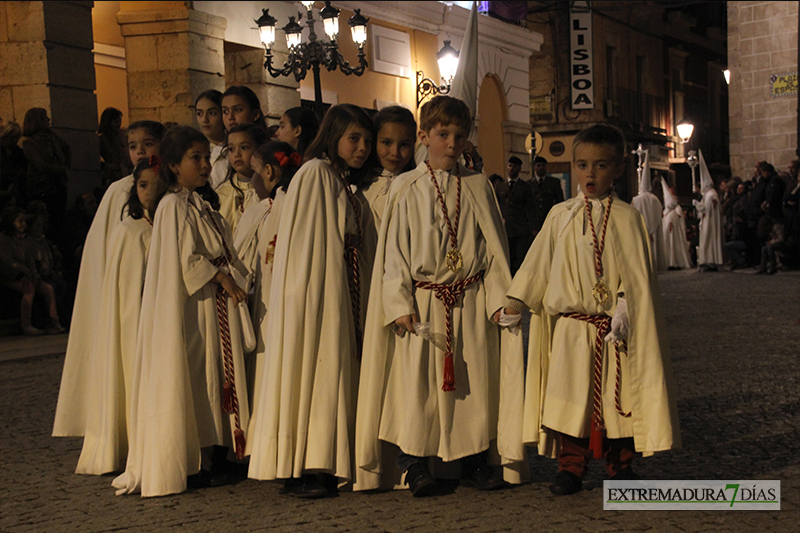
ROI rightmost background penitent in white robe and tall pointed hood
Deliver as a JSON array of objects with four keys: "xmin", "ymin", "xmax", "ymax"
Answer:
[{"xmin": 692, "ymin": 150, "xmax": 725, "ymax": 272}]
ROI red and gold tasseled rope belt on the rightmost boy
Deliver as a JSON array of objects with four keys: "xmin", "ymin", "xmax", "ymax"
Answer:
[{"xmin": 561, "ymin": 313, "xmax": 631, "ymax": 459}]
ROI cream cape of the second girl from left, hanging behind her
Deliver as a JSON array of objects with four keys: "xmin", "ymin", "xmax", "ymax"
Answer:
[{"xmin": 75, "ymin": 217, "xmax": 153, "ymax": 475}]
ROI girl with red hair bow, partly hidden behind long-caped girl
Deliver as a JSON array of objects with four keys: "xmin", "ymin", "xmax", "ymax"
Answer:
[{"xmin": 233, "ymin": 141, "xmax": 301, "ymax": 436}]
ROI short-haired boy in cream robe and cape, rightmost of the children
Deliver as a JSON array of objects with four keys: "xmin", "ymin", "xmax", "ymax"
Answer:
[{"xmin": 506, "ymin": 125, "xmax": 680, "ymax": 494}]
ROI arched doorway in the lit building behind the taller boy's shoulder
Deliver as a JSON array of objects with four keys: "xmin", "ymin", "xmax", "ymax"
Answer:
[{"xmin": 478, "ymin": 74, "xmax": 508, "ymax": 176}]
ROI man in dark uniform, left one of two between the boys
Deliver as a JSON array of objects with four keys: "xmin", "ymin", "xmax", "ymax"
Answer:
[{"xmin": 495, "ymin": 156, "xmax": 533, "ymax": 275}]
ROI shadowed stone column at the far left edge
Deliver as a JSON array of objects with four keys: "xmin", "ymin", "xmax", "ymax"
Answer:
[{"xmin": 0, "ymin": 2, "xmax": 100, "ymax": 202}]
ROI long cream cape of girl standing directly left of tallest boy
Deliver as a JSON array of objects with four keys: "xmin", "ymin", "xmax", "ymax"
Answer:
[{"xmin": 248, "ymin": 159, "xmax": 368, "ymax": 480}]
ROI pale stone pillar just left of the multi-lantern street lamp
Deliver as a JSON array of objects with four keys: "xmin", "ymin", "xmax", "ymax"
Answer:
[{"xmin": 117, "ymin": 6, "xmax": 227, "ymax": 125}]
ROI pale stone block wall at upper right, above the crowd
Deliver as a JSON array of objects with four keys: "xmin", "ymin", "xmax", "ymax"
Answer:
[{"xmin": 728, "ymin": 2, "xmax": 798, "ymax": 178}]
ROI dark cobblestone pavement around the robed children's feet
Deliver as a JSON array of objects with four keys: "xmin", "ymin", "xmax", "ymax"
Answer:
[{"xmin": 0, "ymin": 272, "xmax": 800, "ymax": 532}]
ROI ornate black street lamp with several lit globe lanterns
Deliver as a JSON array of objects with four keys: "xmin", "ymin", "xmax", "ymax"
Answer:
[{"xmin": 255, "ymin": 2, "xmax": 369, "ymax": 121}]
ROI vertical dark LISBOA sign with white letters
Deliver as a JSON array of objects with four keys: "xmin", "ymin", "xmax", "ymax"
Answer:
[{"xmin": 569, "ymin": 1, "xmax": 594, "ymax": 109}]
